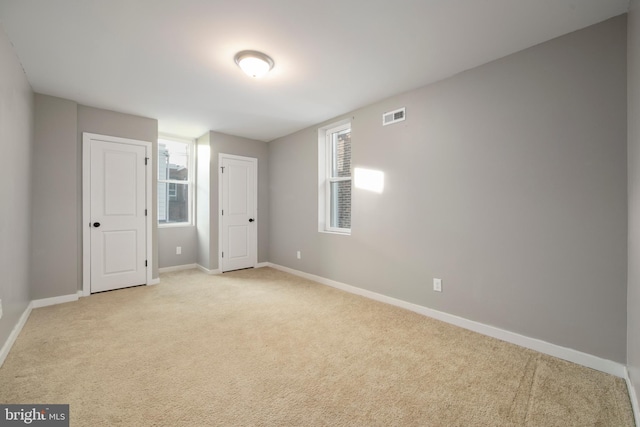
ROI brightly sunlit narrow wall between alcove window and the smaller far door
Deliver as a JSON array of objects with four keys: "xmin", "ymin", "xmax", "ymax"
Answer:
[{"xmin": 196, "ymin": 132, "xmax": 212, "ymax": 270}]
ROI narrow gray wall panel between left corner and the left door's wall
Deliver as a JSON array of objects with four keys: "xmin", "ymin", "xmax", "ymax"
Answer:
[{"xmin": 31, "ymin": 94, "xmax": 82, "ymax": 299}]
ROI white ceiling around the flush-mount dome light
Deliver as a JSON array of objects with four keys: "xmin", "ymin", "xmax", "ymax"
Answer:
[{"xmin": 0, "ymin": 0, "xmax": 629, "ymax": 141}]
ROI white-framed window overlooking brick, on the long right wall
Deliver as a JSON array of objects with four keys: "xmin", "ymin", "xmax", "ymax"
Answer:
[{"xmin": 318, "ymin": 122, "xmax": 351, "ymax": 234}]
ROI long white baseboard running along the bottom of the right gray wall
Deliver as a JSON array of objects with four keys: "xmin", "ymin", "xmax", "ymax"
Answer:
[{"xmin": 269, "ymin": 263, "xmax": 626, "ymax": 378}]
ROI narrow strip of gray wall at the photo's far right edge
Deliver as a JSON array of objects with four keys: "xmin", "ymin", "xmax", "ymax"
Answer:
[{"xmin": 627, "ymin": 0, "xmax": 640, "ymax": 412}]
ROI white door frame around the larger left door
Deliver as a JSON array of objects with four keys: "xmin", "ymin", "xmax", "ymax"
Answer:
[{"xmin": 82, "ymin": 132, "xmax": 154, "ymax": 296}]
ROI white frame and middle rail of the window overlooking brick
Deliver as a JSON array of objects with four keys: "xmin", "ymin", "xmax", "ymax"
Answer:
[{"xmin": 318, "ymin": 119, "xmax": 353, "ymax": 236}]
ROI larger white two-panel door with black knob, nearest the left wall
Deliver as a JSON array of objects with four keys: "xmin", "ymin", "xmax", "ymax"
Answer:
[{"xmin": 89, "ymin": 140, "xmax": 147, "ymax": 292}]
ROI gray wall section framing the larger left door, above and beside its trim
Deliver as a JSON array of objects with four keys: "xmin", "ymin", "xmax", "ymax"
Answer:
[{"xmin": 77, "ymin": 105, "xmax": 158, "ymax": 280}]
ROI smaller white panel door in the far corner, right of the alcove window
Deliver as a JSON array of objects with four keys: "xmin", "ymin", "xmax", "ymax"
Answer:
[{"xmin": 220, "ymin": 154, "xmax": 258, "ymax": 272}]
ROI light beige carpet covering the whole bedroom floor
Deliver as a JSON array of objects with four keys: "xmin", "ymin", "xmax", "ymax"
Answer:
[{"xmin": 0, "ymin": 268, "xmax": 633, "ymax": 427}]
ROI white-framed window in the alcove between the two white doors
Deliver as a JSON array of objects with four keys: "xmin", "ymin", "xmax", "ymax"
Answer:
[{"xmin": 158, "ymin": 136, "xmax": 194, "ymax": 226}]
